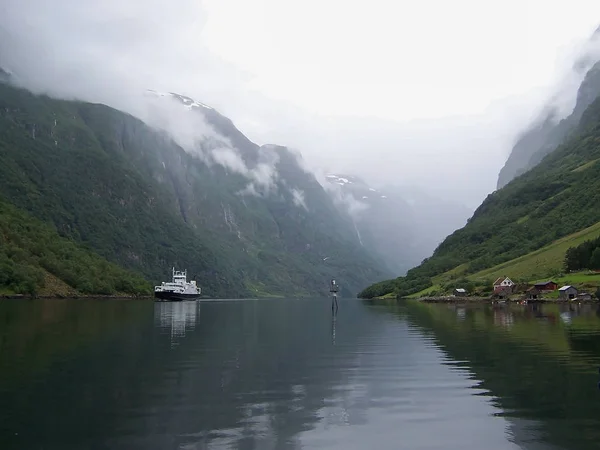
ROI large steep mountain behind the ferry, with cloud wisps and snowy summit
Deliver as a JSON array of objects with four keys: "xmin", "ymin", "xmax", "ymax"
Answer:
[{"xmin": 0, "ymin": 83, "xmax": 387, "ymax": 296}]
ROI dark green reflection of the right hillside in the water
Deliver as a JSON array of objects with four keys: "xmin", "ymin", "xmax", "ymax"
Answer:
[{"xmin": 398, "ymin": 303, "xmax": 600, "ymax": 450}]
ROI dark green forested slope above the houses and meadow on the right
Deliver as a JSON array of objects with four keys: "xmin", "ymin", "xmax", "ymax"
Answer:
[{"xmin": 360, "ymin": 94, "xmax": 600, "ymax": 297}]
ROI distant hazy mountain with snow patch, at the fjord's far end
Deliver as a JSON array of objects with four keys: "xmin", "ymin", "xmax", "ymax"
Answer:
[{"xmin": 326, "ymin": 174, "xmax": 472, "ymax": 274}]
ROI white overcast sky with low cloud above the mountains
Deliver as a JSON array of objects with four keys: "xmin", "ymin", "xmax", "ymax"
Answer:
[{"xmin": 0, "ymin": 0, "xmax": 600, "ymax": 207}]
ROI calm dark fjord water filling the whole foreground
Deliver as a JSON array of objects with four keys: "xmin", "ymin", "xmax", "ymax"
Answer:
[{"xmin": 0, "ymin": 299, "xmax": 600, "ymax": 450}]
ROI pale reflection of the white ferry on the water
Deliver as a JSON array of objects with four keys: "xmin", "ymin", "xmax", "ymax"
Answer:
[{"xmin": 154, "ymin": 301, "xmax": 200, "ymax": 347}]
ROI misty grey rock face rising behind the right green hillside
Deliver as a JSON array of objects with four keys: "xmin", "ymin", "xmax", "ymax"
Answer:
[{"xmin": 498, "ymin": 55, "xmax": 600, "ymax": 188}]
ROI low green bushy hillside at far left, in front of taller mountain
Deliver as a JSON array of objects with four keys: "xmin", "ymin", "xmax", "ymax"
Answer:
[{"xmin": 0, "ymin": 199, "xmax": 151, "ymax": 295}]
